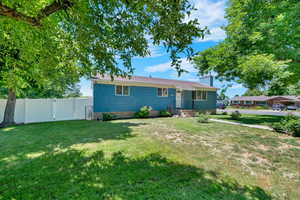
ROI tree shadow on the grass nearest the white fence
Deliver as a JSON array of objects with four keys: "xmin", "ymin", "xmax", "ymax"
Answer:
[{"xmin": 0, "ymin": 121, "xmax": 144, "ymax": 167}]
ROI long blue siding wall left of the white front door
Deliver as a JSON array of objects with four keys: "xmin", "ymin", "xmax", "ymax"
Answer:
[{"xmin": 93, "ymin": 84, "xmax": 176, "ymax": 112}]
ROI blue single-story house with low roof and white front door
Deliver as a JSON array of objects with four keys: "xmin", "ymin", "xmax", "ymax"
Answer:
[{"xmin": 92, "ymin": 75, "xmax": 217, "ymax": 119}]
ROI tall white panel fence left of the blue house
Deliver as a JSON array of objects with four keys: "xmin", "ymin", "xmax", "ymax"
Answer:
[{"xmin": 0, "ymin": 97, "xmax": 93, "ymax": 123}]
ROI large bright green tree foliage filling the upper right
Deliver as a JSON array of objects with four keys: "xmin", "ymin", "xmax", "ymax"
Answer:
[{"xmin": 195, "ymin": 0, "xmax": 300, "ymax": 93}]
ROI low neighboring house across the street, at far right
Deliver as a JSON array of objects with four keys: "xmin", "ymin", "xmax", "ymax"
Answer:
[{"xmin": 231, "ymin": 96, "xmax": 300, "ymax": 107}]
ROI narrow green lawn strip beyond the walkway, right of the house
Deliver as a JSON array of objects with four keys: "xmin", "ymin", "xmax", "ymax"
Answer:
[{"xmin": 211, "ymin": 113, "xmax": 284, "ymax": 126}]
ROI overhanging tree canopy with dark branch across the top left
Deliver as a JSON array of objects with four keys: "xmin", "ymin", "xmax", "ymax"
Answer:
[{"xmin": 0, "ymin": 0, "xmax": 205, "ymax": 75}]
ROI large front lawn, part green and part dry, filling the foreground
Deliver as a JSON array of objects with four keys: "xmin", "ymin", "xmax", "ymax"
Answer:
[{"xmin": 0, "ymin": 118, "xmax": 300, "ymax": 200}]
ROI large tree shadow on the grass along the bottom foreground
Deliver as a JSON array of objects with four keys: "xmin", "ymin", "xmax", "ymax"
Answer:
[{"xmin": 0, "ymin": 150, "xmax": 271, "ymax": 200}]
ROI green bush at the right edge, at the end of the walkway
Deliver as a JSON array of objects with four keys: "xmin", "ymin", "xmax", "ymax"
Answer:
[{"xmin": 272, "ymin": 114, "xmax": 300, "ymax": 137}]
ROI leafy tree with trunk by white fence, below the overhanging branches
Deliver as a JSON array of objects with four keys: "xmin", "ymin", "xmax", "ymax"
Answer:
[{"xmin": 0, "ymin": 41, "xmax": 80, "ymax": 126}]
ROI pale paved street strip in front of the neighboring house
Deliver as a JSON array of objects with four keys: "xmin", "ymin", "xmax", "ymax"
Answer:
[{"xmin": 218, "ymin": 109, "xmax": 300, "ymax": 117}]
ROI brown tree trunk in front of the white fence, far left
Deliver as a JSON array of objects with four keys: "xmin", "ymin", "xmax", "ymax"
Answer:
[{"xmin": 0, "ymin": 89, "xmax": 16, "ymax": 128}]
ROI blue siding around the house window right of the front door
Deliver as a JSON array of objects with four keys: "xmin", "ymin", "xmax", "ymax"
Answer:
[{"xmin": 182, "ymin": 91, "xmax": 217, "ymax": 110}]
